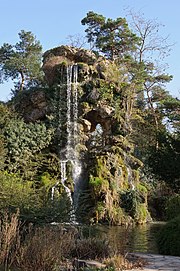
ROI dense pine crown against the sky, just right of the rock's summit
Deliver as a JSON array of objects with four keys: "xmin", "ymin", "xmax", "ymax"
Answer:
[{"xmin": 81, "ymin": 11, "xmax": 139, "ymax": 60}]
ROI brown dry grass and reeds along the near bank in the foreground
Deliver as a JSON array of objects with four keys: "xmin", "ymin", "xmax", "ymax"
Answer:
[{"xmin": 0, "ymin": 212, "xmax": 143, "ymax": 271}]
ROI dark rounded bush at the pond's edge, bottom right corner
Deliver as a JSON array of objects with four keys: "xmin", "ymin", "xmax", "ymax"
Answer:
[{"xmin": 157, "ymin": 216, "xmax": 180, "ymax": 256}]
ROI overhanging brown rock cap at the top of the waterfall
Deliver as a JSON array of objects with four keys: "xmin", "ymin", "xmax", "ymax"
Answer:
[{"xmin": 43, "ymin": 45, "xmax": 116, "ymax": 85}]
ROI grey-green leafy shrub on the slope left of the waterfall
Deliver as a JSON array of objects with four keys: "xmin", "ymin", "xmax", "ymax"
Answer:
[{"xmin": 3, "ymin": 118, "xmax": 53, "ymax": 175}]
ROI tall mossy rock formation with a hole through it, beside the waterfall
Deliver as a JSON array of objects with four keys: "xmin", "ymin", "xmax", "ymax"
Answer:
[{"xmin": 41, "ymin": 46, "xmax": 149, "ymax": 224}]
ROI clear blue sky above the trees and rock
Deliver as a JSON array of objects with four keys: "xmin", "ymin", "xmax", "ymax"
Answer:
[{"xmin": 0, "ymin": 0, "xmax": 180, "ymax": 101}]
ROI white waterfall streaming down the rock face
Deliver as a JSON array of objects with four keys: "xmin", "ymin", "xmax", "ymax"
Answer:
[{"xmin": 52, "ymin": 65, "xmax": 81, "ymax": 221}]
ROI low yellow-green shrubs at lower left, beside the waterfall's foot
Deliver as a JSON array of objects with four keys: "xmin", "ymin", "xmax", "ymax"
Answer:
[{"xmin": 0, "ymin": 172, "xmax": 71, "ymax": 224}]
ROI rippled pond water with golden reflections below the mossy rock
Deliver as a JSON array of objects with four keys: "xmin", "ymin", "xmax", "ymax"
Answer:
[{"xmin": 82, "ymin": 222, "xmax": 164, "ymax": 253}]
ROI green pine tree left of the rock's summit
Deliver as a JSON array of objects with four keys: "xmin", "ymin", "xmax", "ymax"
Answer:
[{"xmin": 0, "ymin": 30, "xmax": 42, "ymax": 92}]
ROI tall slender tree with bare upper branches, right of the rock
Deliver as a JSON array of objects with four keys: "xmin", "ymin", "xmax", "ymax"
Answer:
[{"xmin": 121, "ymin": 11, "xmax": 172, "ymax": 155}]
